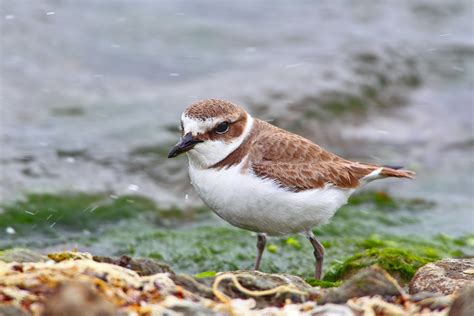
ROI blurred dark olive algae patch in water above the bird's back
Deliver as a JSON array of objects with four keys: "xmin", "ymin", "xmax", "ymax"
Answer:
[{"xmin": 276, "ymin": 51, "xmax": 423, "ymax": 124}]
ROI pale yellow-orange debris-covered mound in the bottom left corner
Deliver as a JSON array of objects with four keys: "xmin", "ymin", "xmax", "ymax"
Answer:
[{"xmin": 0, "ymin": 259, "xmax": 178, "ymax": 315}]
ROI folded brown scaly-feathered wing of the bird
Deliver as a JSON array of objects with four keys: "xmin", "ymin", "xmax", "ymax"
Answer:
[{"xmin": 251, "ymin": 121, "xmax": 379, "ymax": 191}]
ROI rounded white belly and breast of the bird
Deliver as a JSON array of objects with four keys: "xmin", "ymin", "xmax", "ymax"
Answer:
[{"xmin": 189, "ymin": 159, "xmax": 354, "ymax": 235}]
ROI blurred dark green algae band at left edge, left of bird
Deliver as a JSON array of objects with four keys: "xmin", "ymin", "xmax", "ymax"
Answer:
[{"xmin": 0, "ymin": 192, "xmax": 208, "ymax": 238}]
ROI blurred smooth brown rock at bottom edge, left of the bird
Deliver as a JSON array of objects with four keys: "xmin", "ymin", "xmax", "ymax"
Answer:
[{"xmin": 42, "ymin": 282, "xmax": 117, "ymax": 316}]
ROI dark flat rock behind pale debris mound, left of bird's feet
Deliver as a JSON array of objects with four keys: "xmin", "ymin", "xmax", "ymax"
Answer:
[{"xmin": 92, "ymin": 256, "xmax": 174, "ymax": 276}]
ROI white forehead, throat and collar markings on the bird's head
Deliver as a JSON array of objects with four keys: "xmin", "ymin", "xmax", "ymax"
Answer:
[{"xmin": 183, "ymin": 113, "xmax": 253, "ymax": 169}]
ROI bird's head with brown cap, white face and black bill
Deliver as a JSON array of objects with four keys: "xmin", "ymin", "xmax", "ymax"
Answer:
[{"xmin": 168, "ymin": 99, "xmax": 253, "ymax": 168}]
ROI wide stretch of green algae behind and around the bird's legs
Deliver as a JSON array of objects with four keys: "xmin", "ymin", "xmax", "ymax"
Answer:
[{"xmin": 0, "ymin": 192, "xmax": 474, "ymax": 287}]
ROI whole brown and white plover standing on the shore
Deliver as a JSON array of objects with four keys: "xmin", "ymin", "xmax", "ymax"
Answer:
[{"xmin": 168, "ymin": 99, "xmax": 415, "ymax": 279}]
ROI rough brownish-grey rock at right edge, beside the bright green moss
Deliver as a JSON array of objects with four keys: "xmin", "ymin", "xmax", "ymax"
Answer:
[{"xmin": 409, "ymin": 258, "xmax": 474, "ymax": 295}]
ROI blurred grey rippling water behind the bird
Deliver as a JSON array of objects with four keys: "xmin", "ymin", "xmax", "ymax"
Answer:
[{"xmin": 0, "ymin": 0, "xmax": 474, "ymax": 274}]
